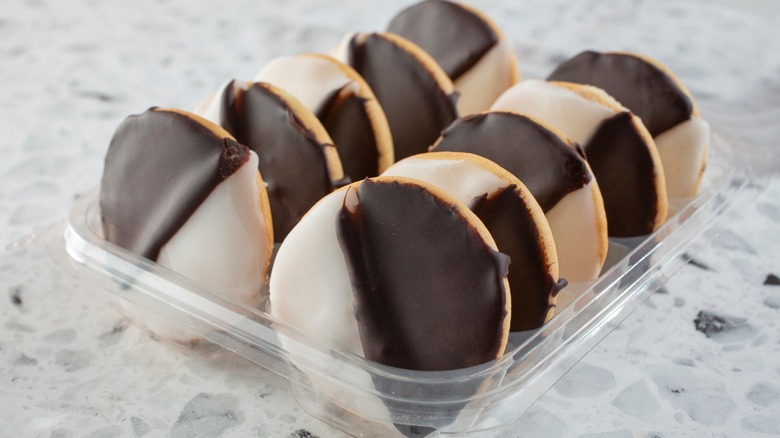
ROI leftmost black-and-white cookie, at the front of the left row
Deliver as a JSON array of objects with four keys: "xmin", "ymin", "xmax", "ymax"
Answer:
[{"xmin": 100, "ymin": 108, "xmax": 273, "ymax": 341}]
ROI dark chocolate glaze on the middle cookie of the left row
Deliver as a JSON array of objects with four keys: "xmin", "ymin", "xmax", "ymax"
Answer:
[{"xmin": 317, "ymin": 85, "xmax": 379, "ymax": 181}]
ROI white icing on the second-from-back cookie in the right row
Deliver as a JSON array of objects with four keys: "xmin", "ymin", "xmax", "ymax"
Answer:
[{"xmin": 490, "ymin": 80, "xmax": 615, "ymax": 144}]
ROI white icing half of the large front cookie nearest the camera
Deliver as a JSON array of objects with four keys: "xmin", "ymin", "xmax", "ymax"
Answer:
[{"xmin": 270, "ymin": 188, "xmax": 389, "ymax": 422}]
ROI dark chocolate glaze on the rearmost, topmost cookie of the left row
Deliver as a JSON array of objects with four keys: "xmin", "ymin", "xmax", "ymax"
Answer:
[{"xmin": 387, "ymin": 0, "xmax": 498, "ymax": 81}]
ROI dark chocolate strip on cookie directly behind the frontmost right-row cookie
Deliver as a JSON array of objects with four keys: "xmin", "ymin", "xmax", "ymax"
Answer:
[{"xmin": 469, "ymin": 185, "xmax": 557, "ymax": 332}]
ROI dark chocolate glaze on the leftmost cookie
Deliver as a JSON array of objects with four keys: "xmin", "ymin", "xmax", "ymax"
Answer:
[{"xmin": 100, "ymin": 108, "xmax": 249, "ymax": 260}]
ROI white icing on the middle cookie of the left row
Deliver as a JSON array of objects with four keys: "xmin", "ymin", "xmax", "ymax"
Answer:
[{"xmin": 255, "ymin": 56, "xmax": 359, "ymax": 112}]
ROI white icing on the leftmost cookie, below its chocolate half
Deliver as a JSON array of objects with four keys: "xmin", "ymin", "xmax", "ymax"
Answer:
[{"xmin": 123, "ymin": 152, "xmax": 273, "ymax": 342}]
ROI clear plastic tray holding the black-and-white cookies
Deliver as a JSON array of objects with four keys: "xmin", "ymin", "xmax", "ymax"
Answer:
[{"xmin": 36, "ymin": 120, "xmax": 771, "ymax": 436}]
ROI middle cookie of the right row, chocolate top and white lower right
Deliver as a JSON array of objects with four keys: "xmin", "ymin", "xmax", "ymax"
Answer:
[{"xmin": 431, "ymin": 111, "xmax": 608, "ymax": 284}]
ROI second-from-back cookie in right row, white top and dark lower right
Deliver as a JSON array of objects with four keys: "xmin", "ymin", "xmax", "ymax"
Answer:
[{"xmin": 492, "ymin": 80, "xmax": 668, "ymax": 237}]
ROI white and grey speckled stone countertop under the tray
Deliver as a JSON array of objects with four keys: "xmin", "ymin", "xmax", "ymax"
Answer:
[{"xmin": 0, "ymin": 0, "xmax": 780, "ymax": 438}]
